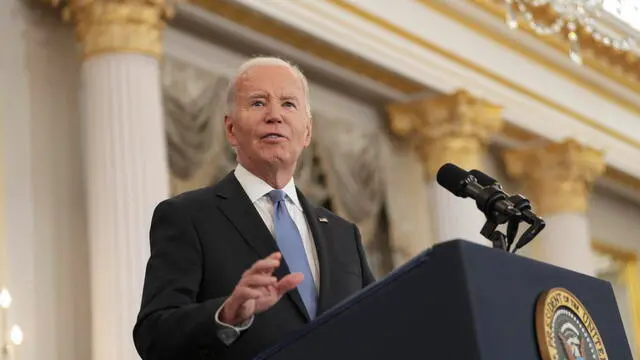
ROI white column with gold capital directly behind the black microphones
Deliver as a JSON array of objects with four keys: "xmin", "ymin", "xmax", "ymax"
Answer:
[{"xmin": 388, "ymin": 91, "xmax": 503, "ymax": 245}]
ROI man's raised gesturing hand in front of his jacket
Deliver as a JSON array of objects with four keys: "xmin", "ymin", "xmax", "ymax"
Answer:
[{"xmin": 220, "ymin": 252, "xmax": 304, "ymax": 325}]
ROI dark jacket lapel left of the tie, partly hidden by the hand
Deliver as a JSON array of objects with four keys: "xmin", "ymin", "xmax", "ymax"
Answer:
[{"xmin": 217, "ymin": 172, "xmax": 315, "ymax": 321}]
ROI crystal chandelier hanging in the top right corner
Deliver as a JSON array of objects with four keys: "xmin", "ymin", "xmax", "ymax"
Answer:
[{"xmin": 504, "ymin": 0, "xmax": 640, "ymax": 65}]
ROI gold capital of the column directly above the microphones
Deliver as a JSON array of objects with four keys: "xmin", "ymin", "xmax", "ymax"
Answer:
[{"xmin": 387, "ymin": 91, "xmax": 503, "ymax": 179}]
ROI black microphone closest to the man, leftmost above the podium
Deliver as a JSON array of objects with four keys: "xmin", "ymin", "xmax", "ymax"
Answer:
[{"xmin": 436, "ymin": 163, "xmax": 520, "ymax": 217}]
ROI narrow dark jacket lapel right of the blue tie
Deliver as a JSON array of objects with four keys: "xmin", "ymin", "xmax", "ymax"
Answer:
[{"xmin": 297, "ymin": 189, "xmax": 330, "ymax": 315}]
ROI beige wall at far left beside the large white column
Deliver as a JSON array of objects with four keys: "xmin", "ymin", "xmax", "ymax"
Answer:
[{"xmin": 0, "ymin": 0, "xmax": 90, "ymax": 360}]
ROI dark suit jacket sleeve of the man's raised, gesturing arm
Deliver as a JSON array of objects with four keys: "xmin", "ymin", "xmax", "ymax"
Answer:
[{"xmin": 133, "ymin": 200, "xmax": 225, "ymax": 360}]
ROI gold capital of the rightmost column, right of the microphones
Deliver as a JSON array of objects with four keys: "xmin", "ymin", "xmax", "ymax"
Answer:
[{"xmin": 503, "ymin": 140, "xmax": 606, "ymax": 215}]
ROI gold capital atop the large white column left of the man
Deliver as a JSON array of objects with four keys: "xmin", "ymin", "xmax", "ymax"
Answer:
[{"xmin": 49, "ymin": 0, "xmax": 179, "ymax": 59}]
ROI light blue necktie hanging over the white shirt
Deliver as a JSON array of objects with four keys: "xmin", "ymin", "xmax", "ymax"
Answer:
[{"xmin": 269, "ymin": 190, "xmax": 318, "ymax": 319}]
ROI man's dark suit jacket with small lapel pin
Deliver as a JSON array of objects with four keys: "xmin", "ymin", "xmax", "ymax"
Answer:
[{"xmin": 133, "ymin": 172, "xmax": 374, "ymax": 360}]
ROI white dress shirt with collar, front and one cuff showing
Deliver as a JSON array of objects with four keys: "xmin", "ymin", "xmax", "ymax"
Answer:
[{"xmin": 215, "ymin": 164, "xmax": 320, "ymax": 345}]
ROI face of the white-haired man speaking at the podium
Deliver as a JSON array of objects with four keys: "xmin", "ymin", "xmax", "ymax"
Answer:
[{"xmin": 225, "ymin": 65, "xmax": 311, "ymax": 173}]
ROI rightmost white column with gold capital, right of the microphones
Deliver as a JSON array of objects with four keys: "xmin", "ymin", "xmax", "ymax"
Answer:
[{"xmin": 504, "ymin": 140, "xmax": 605, "ymax": 275}]
